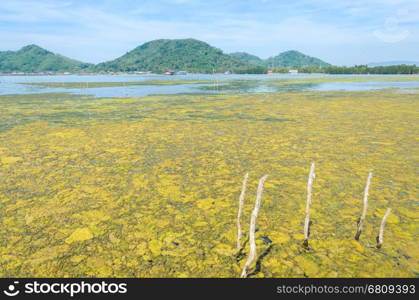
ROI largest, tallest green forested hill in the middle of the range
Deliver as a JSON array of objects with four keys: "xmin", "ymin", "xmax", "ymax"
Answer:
[{"xmin": 95, "ymin": 39, "xmax": 249, "ymax": 73}]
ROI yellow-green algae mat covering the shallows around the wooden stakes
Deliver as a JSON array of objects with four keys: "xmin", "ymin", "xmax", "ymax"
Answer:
[{"xmin": 0, "ymin": 90, "xmax": 419, "ymax": 277}]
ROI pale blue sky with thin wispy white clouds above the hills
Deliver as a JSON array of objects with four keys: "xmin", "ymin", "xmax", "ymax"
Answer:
[{"xmin": 0, "ymin": 0, "xmax": 419, "ymax": 65}]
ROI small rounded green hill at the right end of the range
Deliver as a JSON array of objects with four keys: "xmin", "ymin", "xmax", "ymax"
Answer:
[{"xmin": 265, "ymin": 50, "xmax": 330, "ymax": 68}]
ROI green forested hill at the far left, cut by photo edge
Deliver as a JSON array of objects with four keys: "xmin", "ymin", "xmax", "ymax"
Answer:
[{"xmin": 0, "ymin": 45, "xmax": 91, "ymax": 72}]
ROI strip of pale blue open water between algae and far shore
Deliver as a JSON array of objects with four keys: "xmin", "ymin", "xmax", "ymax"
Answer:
[{"xmin": 0, "ymin": 74, "xmax": 419, "ymax": 97}]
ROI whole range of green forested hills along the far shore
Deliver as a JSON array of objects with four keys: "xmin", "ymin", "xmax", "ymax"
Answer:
[{"xmin": 0, "ymin": 39, "xmax": 330, "ymax": 73}]
